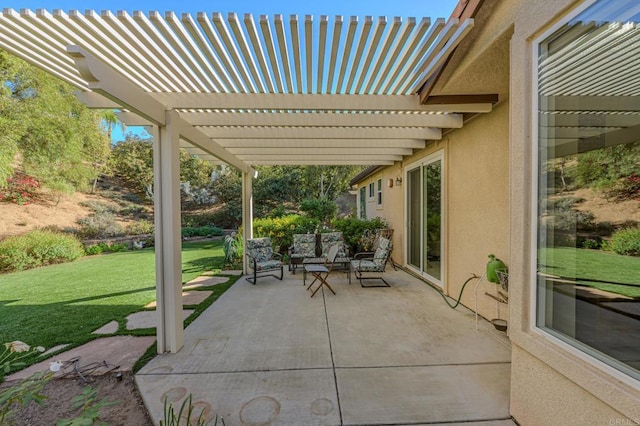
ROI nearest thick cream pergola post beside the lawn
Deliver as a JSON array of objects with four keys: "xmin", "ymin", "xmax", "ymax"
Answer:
[{"xmin": 153, "ymin": 111, "xmax": 184, "ymax": 353}]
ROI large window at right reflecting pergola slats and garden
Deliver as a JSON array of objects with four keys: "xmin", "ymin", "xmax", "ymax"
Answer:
[{"xmin": 534, "ymin": 0, "xmax": 640, "ymax": 378}]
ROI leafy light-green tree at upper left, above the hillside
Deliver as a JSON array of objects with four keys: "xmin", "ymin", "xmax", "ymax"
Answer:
[{"xmin": 0, "ymin": 52, "xmax": 109, "ymax": 191}]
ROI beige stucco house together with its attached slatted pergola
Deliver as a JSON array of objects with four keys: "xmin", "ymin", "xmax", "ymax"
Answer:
[{"xmin": 0, "ymin": 0, "xmax": 640, "ymax": 425}]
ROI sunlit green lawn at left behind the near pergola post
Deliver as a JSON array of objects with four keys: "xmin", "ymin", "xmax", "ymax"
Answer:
[{"xmin": 0, "ymin": 240, "xmax": 235, "ymax": 368}]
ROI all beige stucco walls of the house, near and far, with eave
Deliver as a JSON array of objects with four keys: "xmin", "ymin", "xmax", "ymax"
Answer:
[{"xmin": 356, "ymin": 0, "xmax": 640, "ymax": 425}]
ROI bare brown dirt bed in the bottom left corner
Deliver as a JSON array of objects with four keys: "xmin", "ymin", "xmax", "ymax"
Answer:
[{"xmin": 1, "ymin": 372, "xmax": 153, "ymax": 426}]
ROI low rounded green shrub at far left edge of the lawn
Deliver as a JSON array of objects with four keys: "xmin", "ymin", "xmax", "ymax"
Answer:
[{"xmin": 0, "ymin": 230, "xmax": 84, "ymax": 272}]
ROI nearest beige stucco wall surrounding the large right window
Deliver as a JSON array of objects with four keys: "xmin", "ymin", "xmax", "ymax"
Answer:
[{"xmin": 509, "ymin": 0, "xmax": 640, "ymax": 425}]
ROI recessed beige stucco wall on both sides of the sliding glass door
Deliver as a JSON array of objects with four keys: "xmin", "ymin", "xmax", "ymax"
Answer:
[{"xmin": 360, "ymin": 102, "xmax": 509, "ymax": 319}]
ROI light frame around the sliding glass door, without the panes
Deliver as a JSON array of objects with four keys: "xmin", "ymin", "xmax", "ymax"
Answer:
[{"xmin": 404, "ymin": 149, "xmax": 446, "ymax": 287}]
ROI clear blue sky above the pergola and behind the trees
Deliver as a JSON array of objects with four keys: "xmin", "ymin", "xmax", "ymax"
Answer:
[{"xmin": 10, "ymin": 0, "xmax": 458, "ymax": 142}]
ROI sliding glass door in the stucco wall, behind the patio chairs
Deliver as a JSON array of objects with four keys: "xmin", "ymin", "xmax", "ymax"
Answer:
[{"xmin": 406, "ymin": 152, "xmax": 444, "ymax": 285}]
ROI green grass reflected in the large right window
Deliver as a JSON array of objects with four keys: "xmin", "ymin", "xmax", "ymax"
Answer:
[{"xmin": 539, "ymin": 247, "xmax": 640, "ymax": 298}]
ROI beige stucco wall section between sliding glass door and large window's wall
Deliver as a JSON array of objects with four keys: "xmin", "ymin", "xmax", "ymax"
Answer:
[{"xmin": 445, "ymin": 102, "xmax": 509, "ymax": 319}]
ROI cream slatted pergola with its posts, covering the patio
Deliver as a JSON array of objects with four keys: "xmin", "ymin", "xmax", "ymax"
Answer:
[{"xmin": 0, "ymin": 9, "xmax": 497, "ymax": 352}]
